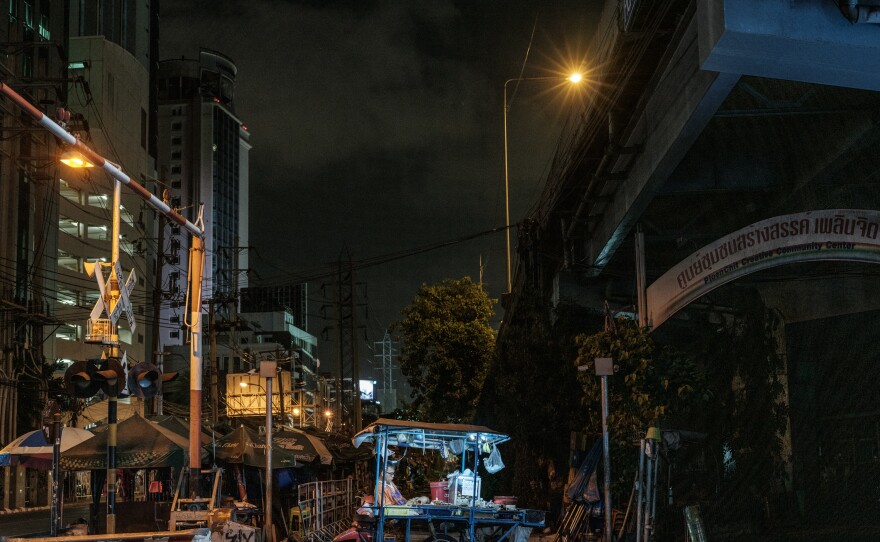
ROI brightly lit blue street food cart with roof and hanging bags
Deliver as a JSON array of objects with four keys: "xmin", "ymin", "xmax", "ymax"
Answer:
[{"xmin": 352, "ymin": 419, "xmax": 545, "ymax": 542}]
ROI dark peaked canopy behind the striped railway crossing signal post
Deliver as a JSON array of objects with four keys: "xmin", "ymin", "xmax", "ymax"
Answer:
[{"xmin": 61, "ymin": 414, "xmax": 201, "ymax": 470}]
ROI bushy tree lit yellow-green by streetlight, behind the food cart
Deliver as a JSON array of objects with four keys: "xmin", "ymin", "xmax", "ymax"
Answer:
[{"xmin": 393, "ymin": 277, "xmax": 496, "ymax": 422}]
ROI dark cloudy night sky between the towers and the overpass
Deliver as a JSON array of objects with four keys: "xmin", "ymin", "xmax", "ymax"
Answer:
[{"xmin": 160, "ymin": 0, "xmax": 602, "ymax": 366}]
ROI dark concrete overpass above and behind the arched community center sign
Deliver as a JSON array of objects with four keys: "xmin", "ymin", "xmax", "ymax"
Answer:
[{"xmin": 524, "ymin": 0, "xmax": 880, "ymax": 528}]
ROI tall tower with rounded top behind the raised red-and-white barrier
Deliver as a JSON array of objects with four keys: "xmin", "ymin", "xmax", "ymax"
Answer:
[{"xmin": 158, "ymin": 50, "xmax": 251, "ymax": 349}]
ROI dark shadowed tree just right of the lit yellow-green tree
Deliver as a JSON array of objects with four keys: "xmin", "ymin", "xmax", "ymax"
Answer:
[{"xmin": 477, "ymin": 294, "xmax": 595, "ymax": 510}]
